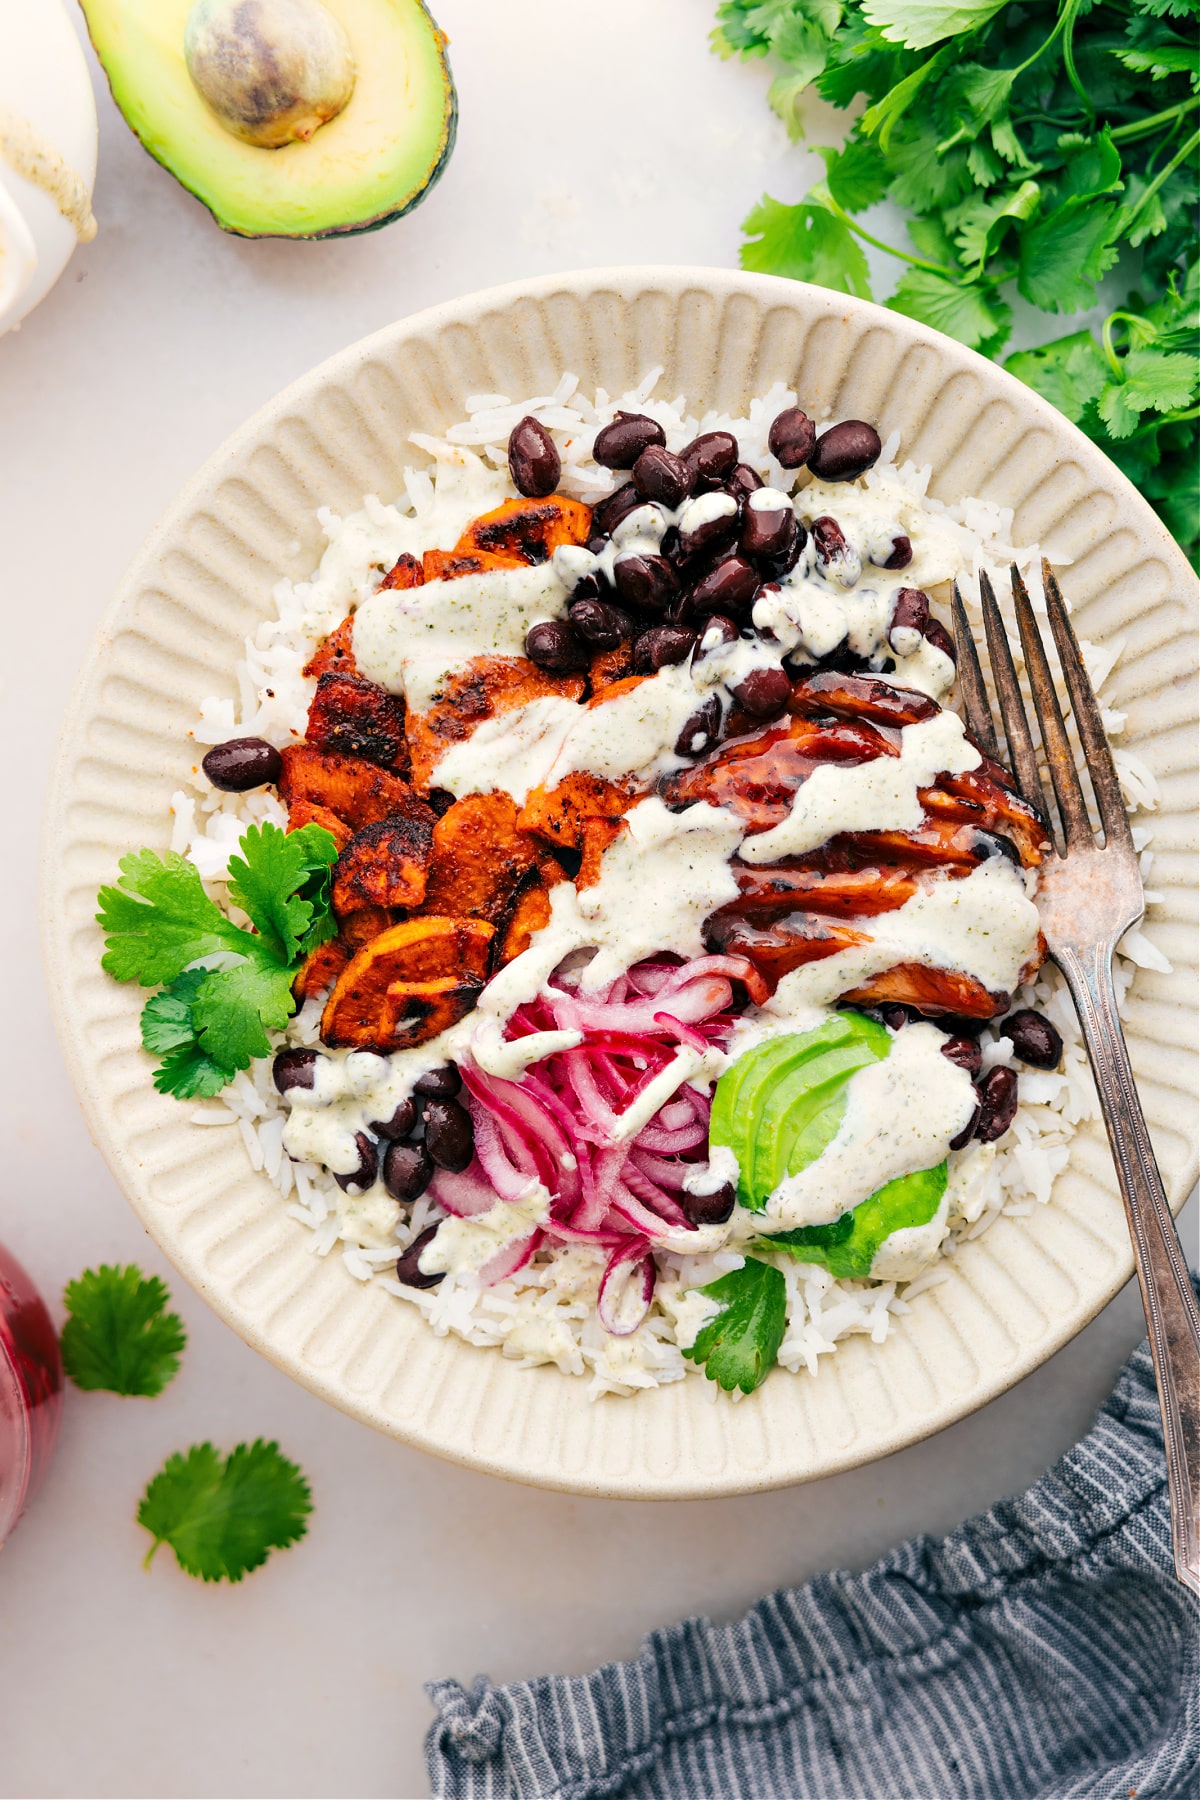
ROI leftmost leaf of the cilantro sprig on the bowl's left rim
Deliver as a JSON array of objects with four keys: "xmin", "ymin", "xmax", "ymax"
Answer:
[{"xmin": 95, "ymin": 850, "xmax": 248, "ymax": 988}]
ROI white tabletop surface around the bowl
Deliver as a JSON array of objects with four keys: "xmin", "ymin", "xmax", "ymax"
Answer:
[{"xmin": 0, "ymin": 0, "xmax": 1195, "ymax": 1796}]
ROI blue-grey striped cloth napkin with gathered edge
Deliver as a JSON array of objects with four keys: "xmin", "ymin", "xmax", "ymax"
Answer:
[{"xmin": 426, "ymin": 1281, "xmax": 1200, "ymax": 1800}]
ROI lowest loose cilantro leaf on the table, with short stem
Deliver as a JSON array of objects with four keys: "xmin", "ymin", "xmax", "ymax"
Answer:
[{"xmin": 137, "ymin": 1438, "xmax": 313, "ymax": 1580}]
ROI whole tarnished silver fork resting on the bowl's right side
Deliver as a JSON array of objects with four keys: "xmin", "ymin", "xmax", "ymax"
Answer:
[{"xmin": 954, "ymin": 558, "xmax": 1200, "ymax": 1593}]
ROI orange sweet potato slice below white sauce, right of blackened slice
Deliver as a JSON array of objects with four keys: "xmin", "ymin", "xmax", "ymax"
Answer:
[{"xmin": 425, "ymin": 794, "xmax": 540, "ymax": 923}]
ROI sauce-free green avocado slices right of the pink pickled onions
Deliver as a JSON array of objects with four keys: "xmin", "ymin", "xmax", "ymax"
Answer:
[{"xmin": 709, "ymin": 1013, "xmax": 891, "ymax": 1211}]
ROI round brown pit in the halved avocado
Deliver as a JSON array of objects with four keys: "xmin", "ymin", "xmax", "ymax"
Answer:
[{"xmin": 184, "ymin": 0, "xmax": 354, "ymax": 149}]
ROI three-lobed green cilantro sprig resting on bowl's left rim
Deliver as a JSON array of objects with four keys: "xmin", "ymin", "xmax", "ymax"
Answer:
[{"xmin": 95, "ymin": 824, "xmax": 336, "ymax": 1100}]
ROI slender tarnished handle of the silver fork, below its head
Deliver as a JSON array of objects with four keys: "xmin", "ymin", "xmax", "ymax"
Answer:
[{"xmin": 1056, "ymin": 945, "xmax": 1200, "ymax": 1593}]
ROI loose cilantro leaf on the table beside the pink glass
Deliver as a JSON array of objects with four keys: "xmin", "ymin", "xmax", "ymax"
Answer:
[{"xmin": 61, "ymin": 1264, "xmax": 187, "ymax": 1399}]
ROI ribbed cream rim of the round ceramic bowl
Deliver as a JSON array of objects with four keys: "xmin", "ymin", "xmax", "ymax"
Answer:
[{"xmin": 43, "ymin": 268, "xmax": 1196, "ymax": 1498}]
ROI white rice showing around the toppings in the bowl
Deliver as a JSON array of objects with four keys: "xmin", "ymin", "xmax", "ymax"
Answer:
[{"xmin": 171, "ymin": 369, "xmax": 1169, "ymax": 1399}]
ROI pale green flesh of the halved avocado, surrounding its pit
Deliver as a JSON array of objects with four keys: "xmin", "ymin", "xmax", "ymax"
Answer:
[{"xmin": 79, "ymin": 0, "xmax": 459, "ymax": 238}]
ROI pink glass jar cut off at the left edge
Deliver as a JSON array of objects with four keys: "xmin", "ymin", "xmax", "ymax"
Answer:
[{"xmin": 0, "ymin": 1246, "xmax": 63, "ymax": 1544}]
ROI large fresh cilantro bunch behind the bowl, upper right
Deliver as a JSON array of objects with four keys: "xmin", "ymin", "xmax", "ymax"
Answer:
[{"xmin": 712, "ymin": 0, "xmax": 1200, "ymax": 560}]
